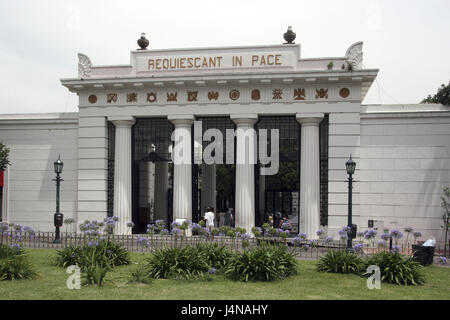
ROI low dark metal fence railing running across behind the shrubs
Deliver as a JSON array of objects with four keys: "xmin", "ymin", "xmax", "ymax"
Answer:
[{"xmin": 0, "ymin": 231, "xmax": 450, "ymax": 259}]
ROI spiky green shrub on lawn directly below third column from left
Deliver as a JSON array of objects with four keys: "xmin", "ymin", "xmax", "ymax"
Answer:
[{"xmin": 225, "ymin": 245, "xmax": 297, "ymax": 281}]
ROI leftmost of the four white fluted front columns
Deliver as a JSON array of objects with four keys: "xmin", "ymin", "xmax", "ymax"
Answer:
[{"xmin": 109, "ymin": 116, "xmax": 135, "ymax": 235}]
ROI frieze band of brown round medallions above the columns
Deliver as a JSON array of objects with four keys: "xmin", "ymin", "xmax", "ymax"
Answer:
[{"xmin": 83, "ymin": 84, "xmax": 360, "ymax": 105}]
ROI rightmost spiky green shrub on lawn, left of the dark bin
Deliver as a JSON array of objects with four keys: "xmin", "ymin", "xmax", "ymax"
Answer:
[{"xmin": 363, "ymin": 251, "xmax": 425, "ymax": 285}]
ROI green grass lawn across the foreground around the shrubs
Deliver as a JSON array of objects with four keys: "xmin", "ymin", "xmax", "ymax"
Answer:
[{"xmin": 0, "ymin": 249, "xmax": 450, "ymax": 300}]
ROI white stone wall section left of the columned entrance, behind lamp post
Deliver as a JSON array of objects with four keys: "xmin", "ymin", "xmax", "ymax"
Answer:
[{"xmin": 0, "ymin": 113, "xmax": 78, "ymax": 231}]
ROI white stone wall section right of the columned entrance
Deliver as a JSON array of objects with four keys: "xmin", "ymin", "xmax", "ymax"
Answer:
[{"xmin": 355, "ymin": 105, "xmax": 450, "ymax": 240}]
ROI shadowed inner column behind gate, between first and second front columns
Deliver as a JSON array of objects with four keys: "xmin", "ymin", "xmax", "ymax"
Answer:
[{"xmin": 154, "ymin": 161, "xmax": 169, "ymax": 221}]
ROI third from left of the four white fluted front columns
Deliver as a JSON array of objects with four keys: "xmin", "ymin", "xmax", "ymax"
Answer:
[{"xmin": 230, "ymin": 114, "xmax": 258, "ymax": 232}]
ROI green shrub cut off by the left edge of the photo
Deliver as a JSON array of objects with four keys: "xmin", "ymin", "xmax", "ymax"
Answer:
[{"xmin": 0, "ymin": 254, "xmax": 37, "ymax": 280}]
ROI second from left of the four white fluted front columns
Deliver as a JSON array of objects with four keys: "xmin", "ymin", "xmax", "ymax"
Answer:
[{"xmin": 168, "ymin": 115, "xmax": 194, "ymax": 221}]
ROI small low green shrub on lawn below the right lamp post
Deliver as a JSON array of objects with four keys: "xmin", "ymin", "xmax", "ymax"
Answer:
[{"xmin": 317, "ymin": 250, "xmax": 362, "ymax": 273}]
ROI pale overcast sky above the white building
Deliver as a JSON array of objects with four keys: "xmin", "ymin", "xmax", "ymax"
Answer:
[{"xmin": 0, "ymin": 0, "xmax": 450, "ymax": 113}]
